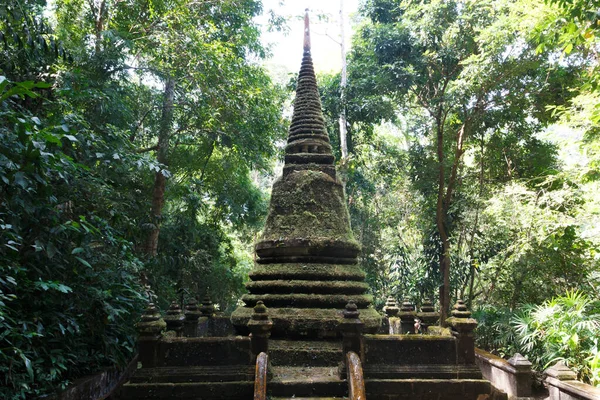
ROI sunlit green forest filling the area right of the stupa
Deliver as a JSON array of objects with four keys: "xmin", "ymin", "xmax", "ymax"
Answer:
[{"xmin": 320, "ymin": 0, "xmax": 600, "ymax": 383}]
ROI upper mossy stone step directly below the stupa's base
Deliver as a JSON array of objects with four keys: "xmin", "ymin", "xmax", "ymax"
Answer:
[{"xmin": 269, "ymin": 340, "xmax": 343, "ymax": 367}]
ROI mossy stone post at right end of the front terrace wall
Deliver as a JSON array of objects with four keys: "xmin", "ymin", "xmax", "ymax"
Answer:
[{"xmin": 446, "ymin": 300, "xmax": 477, "ymax": 364}]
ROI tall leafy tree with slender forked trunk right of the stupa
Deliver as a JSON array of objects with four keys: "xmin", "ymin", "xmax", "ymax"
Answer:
[{"xmin": 342, "ymin": 0, "xmax": 572, "ymax": 316}]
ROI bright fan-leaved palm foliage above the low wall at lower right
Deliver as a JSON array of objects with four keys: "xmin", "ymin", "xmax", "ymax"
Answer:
[{"xmin": 475, "ymin": 291, "xmax": 600, "ymax": 387}]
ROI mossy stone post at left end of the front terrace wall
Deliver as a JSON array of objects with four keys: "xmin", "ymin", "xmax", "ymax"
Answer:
[{"xmin": 136, "ymin": 303, "xmax": 167, "ymax": 368}]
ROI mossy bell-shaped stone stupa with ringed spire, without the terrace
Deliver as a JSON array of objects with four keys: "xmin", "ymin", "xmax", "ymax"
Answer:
[{"xmin": 232, "ymin": 14, "xmax": 381, "ymax": 338}]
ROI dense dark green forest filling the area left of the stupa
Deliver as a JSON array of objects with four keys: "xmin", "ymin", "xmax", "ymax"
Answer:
[{"xmin": 0, "ymin": 0, "xmax": 283, "ymax": 399}]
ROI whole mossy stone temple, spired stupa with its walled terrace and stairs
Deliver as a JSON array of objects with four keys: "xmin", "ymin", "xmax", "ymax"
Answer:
[{"xmin": 120, "ymin": 12, "xmax": 506, "ymax": 400}]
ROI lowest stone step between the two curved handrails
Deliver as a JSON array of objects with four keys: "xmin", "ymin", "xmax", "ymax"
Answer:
[{"xmin": 267, "ymin": 366, "xmax": 348, "ymax": 399}]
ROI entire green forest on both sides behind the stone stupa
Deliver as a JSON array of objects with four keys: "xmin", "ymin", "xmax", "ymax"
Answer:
[{"xmin": 0, "ymin": 0, "xmax": 600, "ymax": 399}]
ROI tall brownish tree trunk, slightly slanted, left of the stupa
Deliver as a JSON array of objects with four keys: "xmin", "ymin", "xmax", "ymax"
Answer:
[{"xmin": 144, "ymin": 78, "xmax": 175, "ymax": 257}]
